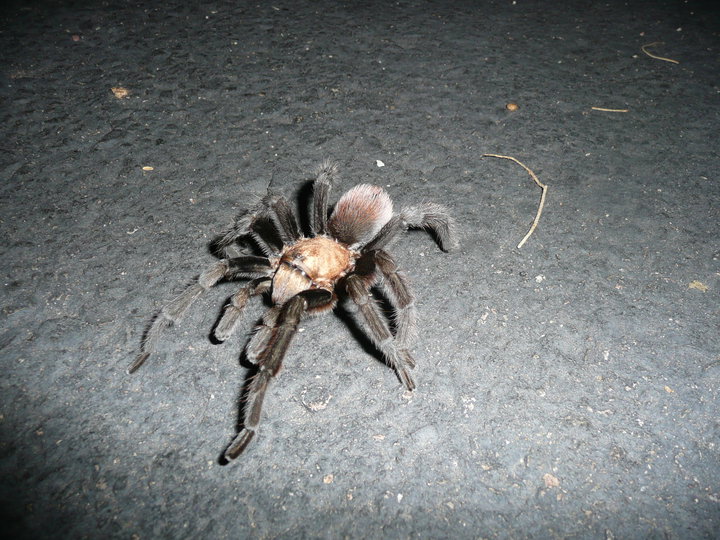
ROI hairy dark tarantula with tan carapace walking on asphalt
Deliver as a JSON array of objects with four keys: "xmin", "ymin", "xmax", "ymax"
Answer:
[{"xmin": 128, "ymin": 161, "xmax": 458, "ymax": 462}]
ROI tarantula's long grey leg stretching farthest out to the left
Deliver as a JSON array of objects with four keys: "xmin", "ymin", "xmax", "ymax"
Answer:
[{"xmin": 127, "ymin": 255, "xmax": 272, "ymax": 373}]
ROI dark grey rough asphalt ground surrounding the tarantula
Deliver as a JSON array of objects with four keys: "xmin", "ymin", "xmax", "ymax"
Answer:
[{"xmin": 0, "ymin": 0, "xmax": 720, "ymax": 539}]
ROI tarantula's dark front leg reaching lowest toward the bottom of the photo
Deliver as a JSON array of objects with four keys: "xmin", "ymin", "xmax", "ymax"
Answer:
[{"xmin": 224, "ymin": 289, "xmax": 333, "ymax": 461}]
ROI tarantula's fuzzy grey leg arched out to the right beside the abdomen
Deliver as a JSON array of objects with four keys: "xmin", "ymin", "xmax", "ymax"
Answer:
[{"xmin": 363, "ymin": 203, "xmax": 458, "ymax": 252}]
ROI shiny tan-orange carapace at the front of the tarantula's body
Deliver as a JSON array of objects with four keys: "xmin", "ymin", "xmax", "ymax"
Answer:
[{"xmin": 272, "ymin": 236, "xmax": 357, "ymax": 304}]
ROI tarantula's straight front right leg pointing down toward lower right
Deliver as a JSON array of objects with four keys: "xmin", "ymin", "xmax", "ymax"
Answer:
[{"xmin": 346, "ymin": 274, "xmax": 415, "ymax": 390}]
